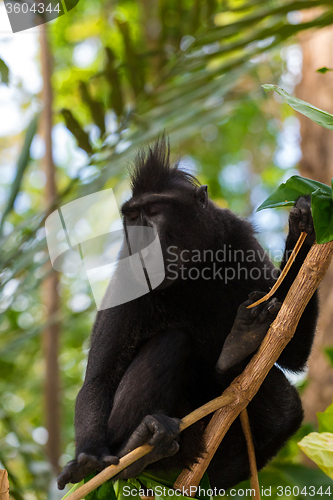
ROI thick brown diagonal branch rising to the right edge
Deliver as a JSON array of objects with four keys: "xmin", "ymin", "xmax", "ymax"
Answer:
[{"xmin": 174, "ymin": 241, "xmax": 333, "ymax": 490}]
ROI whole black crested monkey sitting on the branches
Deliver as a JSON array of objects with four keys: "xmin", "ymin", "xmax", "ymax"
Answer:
[{"xmin": 58, "ymin": 139, "xmax": 317, "ymax": 489}]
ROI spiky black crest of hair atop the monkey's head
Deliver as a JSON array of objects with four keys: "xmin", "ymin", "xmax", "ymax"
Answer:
[{"xmin": 131, "ymin": 134, "xmax": 200, "ymax": 196}]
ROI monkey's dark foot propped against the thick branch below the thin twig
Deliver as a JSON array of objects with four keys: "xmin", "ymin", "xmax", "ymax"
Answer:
[{"xmin": 216, "ymin": 292, "xmax": 281, "ymax": 375}]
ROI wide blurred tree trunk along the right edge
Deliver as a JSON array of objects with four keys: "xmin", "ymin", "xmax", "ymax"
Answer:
[{"xmin": 296, "ymin": 21, "xmax": 333, "ymax": 423}]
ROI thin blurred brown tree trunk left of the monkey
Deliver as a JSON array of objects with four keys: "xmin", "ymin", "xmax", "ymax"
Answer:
[{"xmin": 40, "ymin": 24, "xmax": 60, "ymax": 474}]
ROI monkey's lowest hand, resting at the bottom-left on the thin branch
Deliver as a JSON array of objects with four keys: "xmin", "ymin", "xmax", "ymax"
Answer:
[{"xmin": 57, "ymin": 452, "xmax": 119, "ymax": 490}]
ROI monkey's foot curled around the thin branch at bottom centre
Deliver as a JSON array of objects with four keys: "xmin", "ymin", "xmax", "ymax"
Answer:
[{"xmin": 113, "ymin": 414, "xmax": 180, "ymax": 479}]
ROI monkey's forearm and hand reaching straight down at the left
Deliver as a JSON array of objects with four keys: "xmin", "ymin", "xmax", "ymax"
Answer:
[{"xmin": 58, "ymin": 310, "xmax": 137, "ymax": 489}]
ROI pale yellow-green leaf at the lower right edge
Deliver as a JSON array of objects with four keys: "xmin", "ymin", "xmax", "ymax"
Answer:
[{"xmin": 298, "ymin": 432, "xmax": 333, "ymax": 479}]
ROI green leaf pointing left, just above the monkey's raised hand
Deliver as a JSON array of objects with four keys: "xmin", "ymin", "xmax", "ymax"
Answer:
[{"xmin": 257, "ymin": 175, "xmax": 332, "ymax": 212}]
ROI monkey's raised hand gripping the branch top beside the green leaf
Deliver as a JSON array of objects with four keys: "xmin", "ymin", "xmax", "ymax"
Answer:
[{"xmin": 289, "ymin": 196, "xmax": 316, "ymax": 245}]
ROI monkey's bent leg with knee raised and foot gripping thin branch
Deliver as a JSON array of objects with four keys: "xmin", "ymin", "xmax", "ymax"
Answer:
[{"xmin": 108, "ymin": 330, "xmax": 202, "ymax": 478}]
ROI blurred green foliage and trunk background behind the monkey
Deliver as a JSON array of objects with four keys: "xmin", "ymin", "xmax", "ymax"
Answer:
[{"xmin": 0, "ymin": 0, "xmax": 333, "ymax": 500}]
